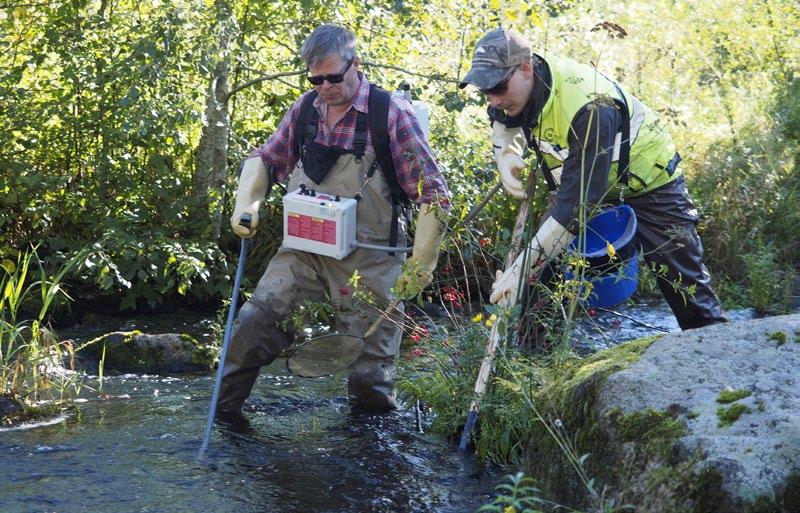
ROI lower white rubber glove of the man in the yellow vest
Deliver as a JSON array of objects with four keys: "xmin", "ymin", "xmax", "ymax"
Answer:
[{"xmin": 489, "ymin": 217, "xmax": 575, "ymax": 307}]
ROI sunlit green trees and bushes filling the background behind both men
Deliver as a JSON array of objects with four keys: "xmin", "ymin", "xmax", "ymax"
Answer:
[{"xmin": 0, "ymin": 0, "xmax": 800, "ymax": 307}]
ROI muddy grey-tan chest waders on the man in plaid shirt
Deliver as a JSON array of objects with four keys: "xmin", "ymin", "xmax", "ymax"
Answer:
[{"xmin": 218, "ymin": 153, "xmax": 406, "ymax": 413}]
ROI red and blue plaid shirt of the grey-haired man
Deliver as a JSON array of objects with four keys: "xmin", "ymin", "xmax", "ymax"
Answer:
[{"xmin": 250, "ymin": 75, "xmax": 450, "ymax": 207}]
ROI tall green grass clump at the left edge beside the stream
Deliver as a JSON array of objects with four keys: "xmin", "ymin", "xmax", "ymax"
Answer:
[{"xmin": 0, "ymin": 248, "xmax": 85, "ymax": 405}]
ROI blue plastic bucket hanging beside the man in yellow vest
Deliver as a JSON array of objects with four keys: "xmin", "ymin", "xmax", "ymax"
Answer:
[{"xmin": 567, "ymin": 205, "xmax": 639, "ymax": 308}]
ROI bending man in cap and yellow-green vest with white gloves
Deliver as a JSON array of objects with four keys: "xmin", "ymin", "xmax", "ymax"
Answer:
[{"xmin": 459, "ymin": 29, "xmax": 726, "ymax": 329}]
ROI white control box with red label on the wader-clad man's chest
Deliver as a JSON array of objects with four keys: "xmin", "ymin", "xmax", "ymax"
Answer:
[{"xmin": 283, "ymin": 184, "xmax": 358, "ymax": 260}]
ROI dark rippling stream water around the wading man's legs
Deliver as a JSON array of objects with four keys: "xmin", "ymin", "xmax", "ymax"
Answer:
[{"xmin": 0, "ymin": 296, "xmax": 764, "ymax": 513}]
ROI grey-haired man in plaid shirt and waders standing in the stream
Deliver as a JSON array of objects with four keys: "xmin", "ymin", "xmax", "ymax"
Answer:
[{"xmin": 218, "ymin": 25, "xmax": 449, "ymax": 419}]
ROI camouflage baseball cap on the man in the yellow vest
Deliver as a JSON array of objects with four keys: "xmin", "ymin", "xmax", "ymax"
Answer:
[{"xmin": 458, "ymin": 29, "xmax": 531, "ymax": 89}]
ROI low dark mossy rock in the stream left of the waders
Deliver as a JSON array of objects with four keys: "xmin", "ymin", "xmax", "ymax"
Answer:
[{"xmin": 80, "ymin": 331, "xmax": 217, "ymax": 374}]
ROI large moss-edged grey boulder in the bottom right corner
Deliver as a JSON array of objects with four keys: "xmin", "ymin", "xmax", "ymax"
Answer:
[{"xmin": 527, "ymin": 315, "xmax": 800, "ymax": 513}]
